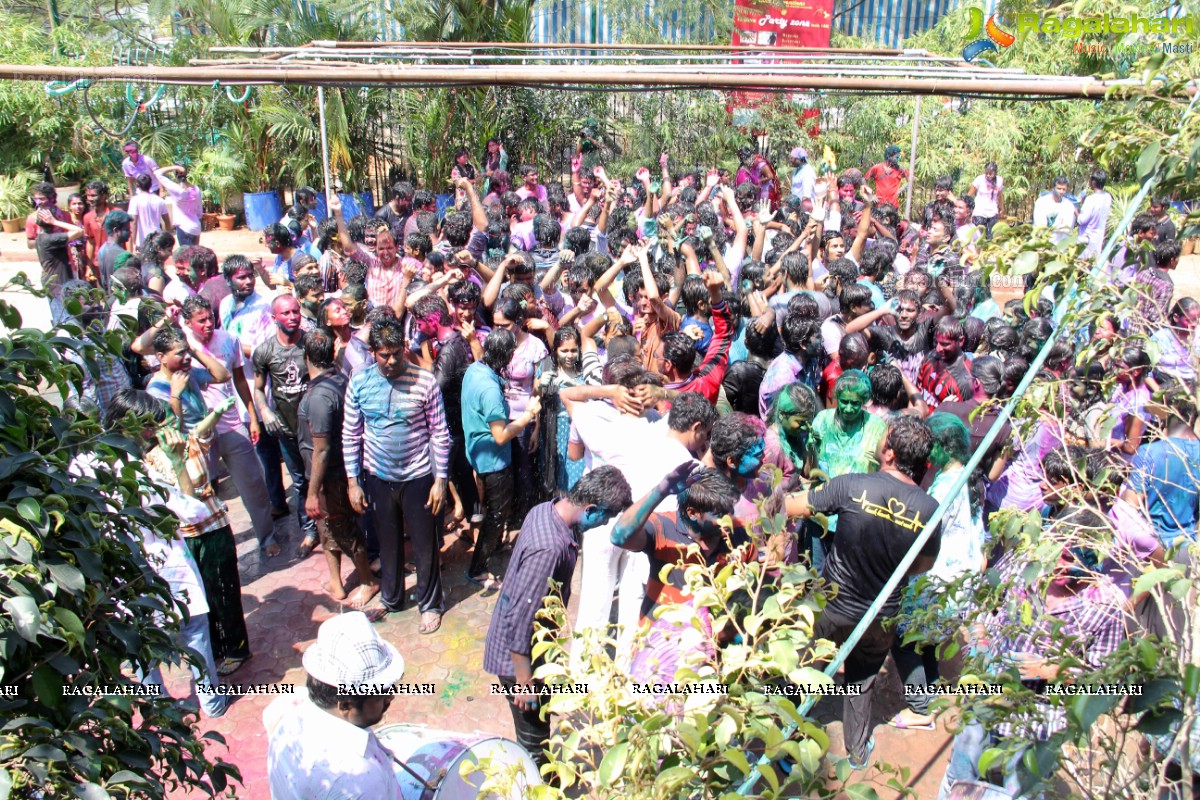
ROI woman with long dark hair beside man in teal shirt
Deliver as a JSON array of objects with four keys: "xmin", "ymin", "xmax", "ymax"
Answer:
[{"xmin": 535, "ymin": 325, "xmax": 584, "ymax": 498}]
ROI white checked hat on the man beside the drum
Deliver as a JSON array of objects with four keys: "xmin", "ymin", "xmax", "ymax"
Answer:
[{"xmin": 302, "ymin": 612, "xmax": 404, "ymax": 686}]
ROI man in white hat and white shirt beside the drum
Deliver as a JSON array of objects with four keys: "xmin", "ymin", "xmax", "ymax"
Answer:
[{"xmin": 263, "ymin": 612, "xmax": 404, "ymax": 800}]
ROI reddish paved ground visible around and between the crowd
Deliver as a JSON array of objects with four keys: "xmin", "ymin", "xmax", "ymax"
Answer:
[{"xmin": 0, "ymin": 225, "xmax": 1200, "ymax": 800}]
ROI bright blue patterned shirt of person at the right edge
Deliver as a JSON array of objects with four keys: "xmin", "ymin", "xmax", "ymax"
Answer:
[{"xmin": 1128, "ymin": 437, "xmax": 1200, "ymax": 547}]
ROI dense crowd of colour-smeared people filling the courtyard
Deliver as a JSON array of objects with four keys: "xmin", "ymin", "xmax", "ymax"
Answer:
[{"xmin": 28, "ymin": 134, "xmax": 1200, "ymax": 786}]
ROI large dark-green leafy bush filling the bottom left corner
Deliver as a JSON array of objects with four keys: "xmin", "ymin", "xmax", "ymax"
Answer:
[{"xmin": 0, "ymin": 284, "xmax": 240, "ymax": 798}]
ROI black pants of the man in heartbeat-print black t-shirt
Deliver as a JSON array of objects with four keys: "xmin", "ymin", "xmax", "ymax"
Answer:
[{"xmin": 812, "ymin": 608, "xmax": 895, "ymax": 758}]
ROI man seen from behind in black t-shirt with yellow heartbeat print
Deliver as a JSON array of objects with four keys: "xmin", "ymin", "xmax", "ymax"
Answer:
[{"xmin": 786, "ymin": 416, "xmax": 942, "ymax": 769}]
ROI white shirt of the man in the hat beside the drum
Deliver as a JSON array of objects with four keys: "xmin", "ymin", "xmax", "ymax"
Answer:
[{"xmin": 263, "ymin": 690, "xmax": 402, "ymax": 800}]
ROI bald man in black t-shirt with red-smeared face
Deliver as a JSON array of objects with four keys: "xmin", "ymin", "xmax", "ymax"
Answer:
[{"xmin": 251, "ymin": 294, "xmax": 318, "ymax": 558}]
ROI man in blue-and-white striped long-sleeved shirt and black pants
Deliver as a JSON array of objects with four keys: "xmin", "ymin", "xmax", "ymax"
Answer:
[{"xmin": 342, "ymin": 319, "xmax": 450, "ymax": 633}]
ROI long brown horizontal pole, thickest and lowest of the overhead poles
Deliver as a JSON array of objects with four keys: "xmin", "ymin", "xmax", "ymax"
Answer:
[{"xmin": 0, "ymin": 64, "xmax": 1118, "ymax": 100}]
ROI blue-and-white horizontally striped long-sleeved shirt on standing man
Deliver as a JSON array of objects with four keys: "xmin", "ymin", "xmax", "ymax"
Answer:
[{"xmin": 342, "ymin": 363, "xmax": 450, "ymax": 482}]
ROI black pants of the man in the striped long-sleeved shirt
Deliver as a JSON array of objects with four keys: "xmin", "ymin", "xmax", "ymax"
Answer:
[{"xmin": 362, "ymin": 474, "xmax": 443, "ymax": 613}]
